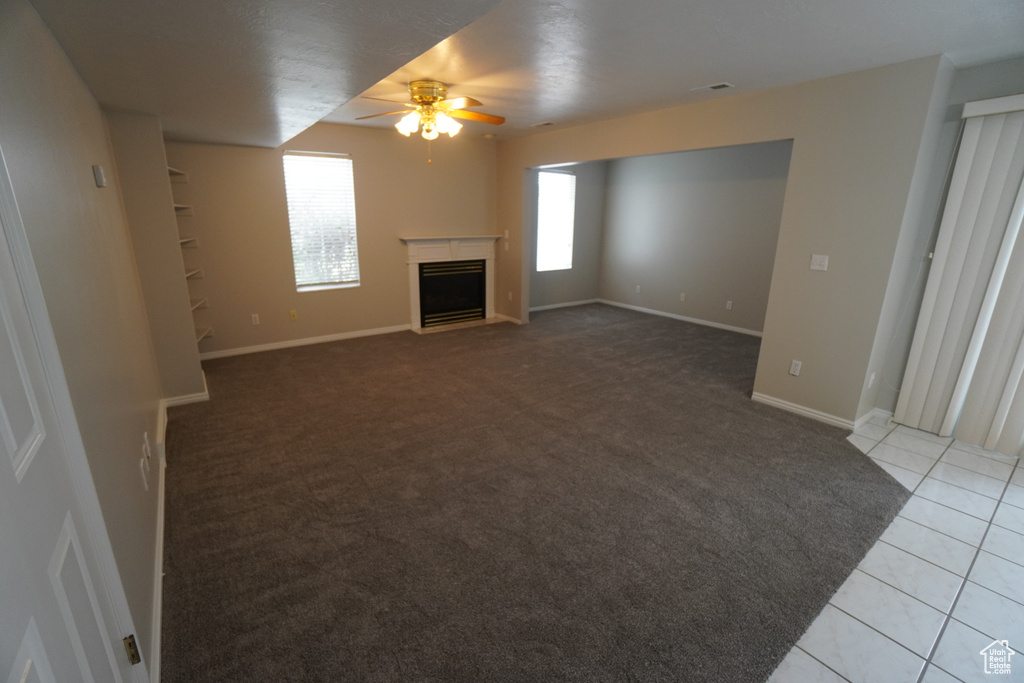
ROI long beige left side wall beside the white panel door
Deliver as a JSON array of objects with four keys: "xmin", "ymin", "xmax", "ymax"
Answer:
[{"xmin": 0, "ymin": 0, "xmax": 161, "ymax": 653}]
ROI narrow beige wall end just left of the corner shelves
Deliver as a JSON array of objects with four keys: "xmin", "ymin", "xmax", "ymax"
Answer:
[{"xmin": 106, "ymin": 112, "xmax": 206, "ymax": 398}]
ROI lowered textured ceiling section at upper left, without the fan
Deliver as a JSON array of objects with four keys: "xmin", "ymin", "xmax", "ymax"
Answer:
[{"xmin": 31, "ymin": 0, "xmax": 507, "ymax": 146}]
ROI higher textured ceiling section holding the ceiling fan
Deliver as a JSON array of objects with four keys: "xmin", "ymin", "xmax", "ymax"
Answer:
[{"xmin": 326, "ymin": 0, "xmax": 1024, "ymax": 137}]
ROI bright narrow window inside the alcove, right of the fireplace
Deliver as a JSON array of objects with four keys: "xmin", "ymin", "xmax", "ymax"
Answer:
[{"xmin": 537, "ymin": 171, "xmax": 575, "ymax": 272}]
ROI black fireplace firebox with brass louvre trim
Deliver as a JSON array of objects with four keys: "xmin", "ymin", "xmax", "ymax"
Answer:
[{"xmin": 420, "ymin": 260, "xmax": 486, "ymax": 328}]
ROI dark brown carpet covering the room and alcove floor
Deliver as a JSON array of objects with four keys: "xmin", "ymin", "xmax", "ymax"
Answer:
[{"xmin": 162, "ymin": 305, "xmax": 908, "ymax": 683}]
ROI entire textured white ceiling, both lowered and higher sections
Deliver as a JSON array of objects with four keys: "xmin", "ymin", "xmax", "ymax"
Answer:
[{"xmin": 32, "ymin": 0, "xmax": 1024, "ymax": 145}]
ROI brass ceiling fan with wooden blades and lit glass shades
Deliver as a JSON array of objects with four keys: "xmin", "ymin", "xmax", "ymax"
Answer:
[{"xmin": 356, "ymin": 80, "xmax": 505, "ymax": 140}]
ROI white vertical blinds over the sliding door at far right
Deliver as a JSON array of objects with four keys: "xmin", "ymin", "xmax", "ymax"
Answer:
[{"xmin": 894, "ymin": 96, "xmax": 1024, "ymax": 455}]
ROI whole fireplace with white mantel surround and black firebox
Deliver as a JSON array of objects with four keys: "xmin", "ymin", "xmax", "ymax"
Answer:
[{"xmin": 400, "ymin": 234, "xmax": 498, "ymax": 331}]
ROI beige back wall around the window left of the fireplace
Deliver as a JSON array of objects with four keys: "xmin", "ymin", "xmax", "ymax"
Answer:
[{"xmin": 167, "ymin": 124, "xmax": 501, "ymax": 353}]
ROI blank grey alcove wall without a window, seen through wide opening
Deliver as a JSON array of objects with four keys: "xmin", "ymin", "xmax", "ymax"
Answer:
[{"xmin": 600, "ymin": 140, "xmax": 793, "ymax": 333}]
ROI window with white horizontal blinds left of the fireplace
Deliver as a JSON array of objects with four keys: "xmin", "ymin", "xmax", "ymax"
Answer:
[{"xmin": 285, "ymin": 152, "xmax": 359, "ymax": 292}]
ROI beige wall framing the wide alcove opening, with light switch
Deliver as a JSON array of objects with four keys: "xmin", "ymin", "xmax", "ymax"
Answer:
[{"xmin": 498, "ymin": 56, "xmax": 940, "ymax": 421}]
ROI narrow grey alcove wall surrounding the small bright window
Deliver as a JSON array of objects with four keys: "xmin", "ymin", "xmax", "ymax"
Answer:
[{"xmin": 528, "ymin": 162, "xmax": 607, "ymax": 308}]
